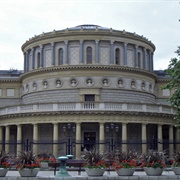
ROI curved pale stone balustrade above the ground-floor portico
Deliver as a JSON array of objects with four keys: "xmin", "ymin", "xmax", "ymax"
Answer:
[{"xmin": 0, "ymin": 102, "xmax": 175, "ymax": 115}]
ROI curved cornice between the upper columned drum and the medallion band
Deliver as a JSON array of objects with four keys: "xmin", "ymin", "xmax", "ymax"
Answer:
[{"xmin": 20, "ymin": 65, "xmax": 157, "ymax": 80}]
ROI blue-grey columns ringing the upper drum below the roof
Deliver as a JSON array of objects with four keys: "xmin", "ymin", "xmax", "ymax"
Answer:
[{"xmin": 24, "ymin": 39, "xmax": 153, "ymax": 72}]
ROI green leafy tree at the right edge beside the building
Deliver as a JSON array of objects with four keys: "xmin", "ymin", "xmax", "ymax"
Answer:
[{"xmin": 163, "ymin": 46, "xmax": 180, "ymax": 126}]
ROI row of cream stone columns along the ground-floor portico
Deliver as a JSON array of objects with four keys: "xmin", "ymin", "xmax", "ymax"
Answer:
[{"xmin": 0, "ymin": 122, "xmax": 176, "ymax": 159}]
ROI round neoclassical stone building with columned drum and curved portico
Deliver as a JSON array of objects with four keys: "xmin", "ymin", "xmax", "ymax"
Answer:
[{"xmin": 0, "ymin": 25, "xmax": 179, "ymax": 158}]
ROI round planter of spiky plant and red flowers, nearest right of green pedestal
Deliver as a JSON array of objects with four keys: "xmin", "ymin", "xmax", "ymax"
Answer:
[{"xmin": 82, "ymin": 148, "xmax": 107, "ymax": 176}]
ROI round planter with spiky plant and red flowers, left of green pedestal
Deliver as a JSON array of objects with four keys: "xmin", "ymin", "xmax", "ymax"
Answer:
[{"xmin": 17, "ymin": 151, "xmax": 40, "ymax": 177}]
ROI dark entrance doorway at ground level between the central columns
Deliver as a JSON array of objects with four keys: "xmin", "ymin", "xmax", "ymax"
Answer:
[{"xmin": 84, "ymin": 132, "xmax": 96, "ymax": 151}]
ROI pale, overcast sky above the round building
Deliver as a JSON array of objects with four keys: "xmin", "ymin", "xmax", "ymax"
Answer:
[{"xmin": 0, "ymin": 0, "xmax": 180, "ymax": 70}]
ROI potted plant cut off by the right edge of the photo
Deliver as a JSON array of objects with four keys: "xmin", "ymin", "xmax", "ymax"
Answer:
[{"xmin": 171, "ymin": 151, "xmax": 180, "ymax": 175}]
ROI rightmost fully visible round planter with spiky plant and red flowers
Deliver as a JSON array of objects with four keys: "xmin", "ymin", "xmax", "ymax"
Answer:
[{"xmin": 140, "ymin": 150, "xmax": 166, "ymax": 176}]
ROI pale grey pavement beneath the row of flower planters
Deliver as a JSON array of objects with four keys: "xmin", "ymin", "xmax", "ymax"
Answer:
[{"xmin": 0, "ymin": 171, "xmax": 180, "ymax": 180}]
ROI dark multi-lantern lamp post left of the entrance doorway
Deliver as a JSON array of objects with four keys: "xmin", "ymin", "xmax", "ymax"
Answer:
[{"xmin": 63, "ymin": 122, "xmax": 76, "ymax": 154}]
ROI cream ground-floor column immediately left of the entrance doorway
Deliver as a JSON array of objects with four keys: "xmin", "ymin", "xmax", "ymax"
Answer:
[{"xmin": 76, "ymin": 123, "xmax": 81, "ymax": 159}]
